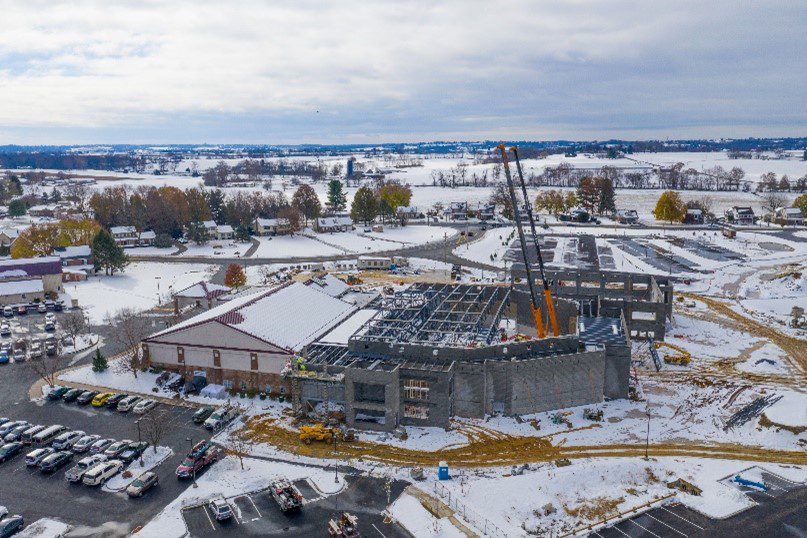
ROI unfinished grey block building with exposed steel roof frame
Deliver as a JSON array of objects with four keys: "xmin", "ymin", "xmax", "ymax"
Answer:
[{"xmin": 286, "ymin": 273, "xmax": 672, "ymax": 431}]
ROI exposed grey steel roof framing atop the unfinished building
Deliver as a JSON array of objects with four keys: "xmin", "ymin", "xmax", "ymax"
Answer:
[{"xmin": 353, "ymin": 284, "xmax": 510, "ymax": 346}]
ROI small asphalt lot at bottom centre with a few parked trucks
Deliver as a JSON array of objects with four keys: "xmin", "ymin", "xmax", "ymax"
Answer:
[{"xmin": 182, "ymin": 476, "xmax": 410, "ymax": 538}]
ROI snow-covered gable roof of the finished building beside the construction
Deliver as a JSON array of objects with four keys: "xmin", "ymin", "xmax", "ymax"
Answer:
[{"xmin": 147, "ymin": 282, "xmax": 356, "ymax": 352}]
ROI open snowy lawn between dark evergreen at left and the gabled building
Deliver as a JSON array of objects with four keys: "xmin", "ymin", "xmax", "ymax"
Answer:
[{"xmin": 65, "ymin": 262, "xmax": 216, "ymax": 323}]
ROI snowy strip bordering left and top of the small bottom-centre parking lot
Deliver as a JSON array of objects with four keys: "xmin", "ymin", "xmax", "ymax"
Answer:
[{"xmin": 137, "ymin": 456, "xmax": 344, "ymax": 538}]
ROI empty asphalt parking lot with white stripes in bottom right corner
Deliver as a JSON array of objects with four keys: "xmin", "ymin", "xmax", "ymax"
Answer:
[{"xmin": 589, "ymin": 471, "xmax": 807, "ymax": 538}]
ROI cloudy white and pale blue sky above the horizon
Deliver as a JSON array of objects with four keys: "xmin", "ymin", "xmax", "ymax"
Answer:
[{"xmin": 0, "ymin": 0, "xmax": 807, "ymax": 144}]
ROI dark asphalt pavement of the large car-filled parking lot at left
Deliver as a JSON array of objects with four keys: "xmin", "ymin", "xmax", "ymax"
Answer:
[{"xmin": 0, "ymin": 352, "xmax": 215, "ymax": 536}]
